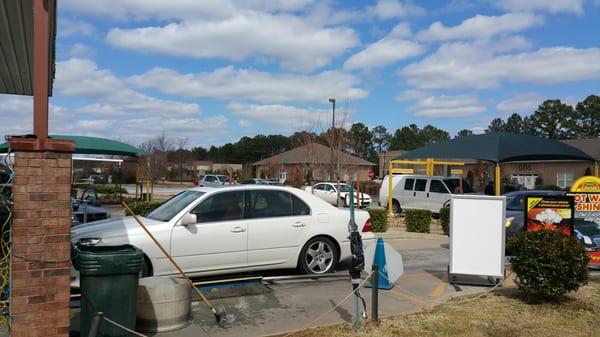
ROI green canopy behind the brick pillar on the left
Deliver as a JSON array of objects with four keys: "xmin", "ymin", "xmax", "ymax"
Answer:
[{"xmin": 0, "ymin": 135, "xmax": 143, "ymax": 156}]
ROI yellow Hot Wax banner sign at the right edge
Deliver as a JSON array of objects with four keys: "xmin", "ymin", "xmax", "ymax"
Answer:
[{"xmin": 568, "ymin": 177, "xmax": 600, "ymax": 267}]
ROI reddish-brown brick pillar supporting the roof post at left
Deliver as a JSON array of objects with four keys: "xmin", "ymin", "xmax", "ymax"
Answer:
[{"xmin": 10, "ymin": 150, "xmax": 71, "ymax": 337}]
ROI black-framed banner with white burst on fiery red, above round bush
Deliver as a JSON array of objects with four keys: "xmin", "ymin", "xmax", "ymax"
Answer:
[{"xmin": 525, "ymin": 195, "xmax": 574, "ymax": 235}]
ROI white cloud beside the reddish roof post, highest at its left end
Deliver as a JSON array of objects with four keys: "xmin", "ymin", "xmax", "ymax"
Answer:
[{"xmin": 54, "ymin": 58, "xmax": 200, "ymax": 116}]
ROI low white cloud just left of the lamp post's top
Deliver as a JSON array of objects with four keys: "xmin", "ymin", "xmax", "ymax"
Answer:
[{"xmin": 227, "ymin": 102, "xmax": 330, "ymax": 131}]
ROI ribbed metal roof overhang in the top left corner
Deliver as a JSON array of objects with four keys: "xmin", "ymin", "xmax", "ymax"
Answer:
[{"xmin": 0, "ymin": 0, "xmax": 56, "ymax": 96}]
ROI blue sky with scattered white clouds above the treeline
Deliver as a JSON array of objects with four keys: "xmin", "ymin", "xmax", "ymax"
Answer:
[{"xmin": 0, "ymin": 0, "xmax": 600, "ymax": 147}]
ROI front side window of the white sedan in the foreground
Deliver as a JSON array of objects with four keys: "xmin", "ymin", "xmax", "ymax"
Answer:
[{"xmin": 190, "ymin": 191, "xmax": 244, "ymax": 223}]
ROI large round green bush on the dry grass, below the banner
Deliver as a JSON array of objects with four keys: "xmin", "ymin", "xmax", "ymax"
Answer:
[{"xmin": 507, "ymin": 231, "xmax": 589, "ymax": 302}]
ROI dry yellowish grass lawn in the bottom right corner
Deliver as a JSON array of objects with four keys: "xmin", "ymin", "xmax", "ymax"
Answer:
[{"xmin": 291, "ymin": 278, "xmax": 600, "ymax": 337}]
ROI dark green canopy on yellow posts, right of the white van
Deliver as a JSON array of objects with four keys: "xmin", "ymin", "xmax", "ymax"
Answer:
[{"xmin": 396, "ymin": 133, "xmax": 594, "ymax": 163}]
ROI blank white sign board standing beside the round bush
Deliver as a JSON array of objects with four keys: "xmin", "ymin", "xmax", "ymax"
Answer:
[{"xmin": 448, "ymin": 195, "xmax": 506, "ymax": 278}]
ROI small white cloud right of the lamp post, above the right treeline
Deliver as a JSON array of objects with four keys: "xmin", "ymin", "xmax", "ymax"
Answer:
[{"xmin": 397, "ymin": 91, "xmax": 486, "ymax": 118}]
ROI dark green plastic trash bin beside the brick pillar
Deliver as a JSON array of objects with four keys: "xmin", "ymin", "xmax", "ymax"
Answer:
[{"xmin": 73, "ymin": 245, "xmax": 144, "ymax": 337}]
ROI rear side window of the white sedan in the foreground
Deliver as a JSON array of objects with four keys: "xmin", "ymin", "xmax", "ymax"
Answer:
[{"xmin": 246, "ymin": 190, "xmax": 292, "ymax": 219}]
